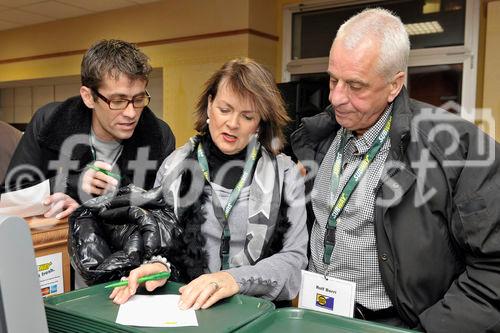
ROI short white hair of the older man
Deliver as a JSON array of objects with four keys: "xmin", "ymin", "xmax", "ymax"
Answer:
[{"xmin": 334, "ymin": 8, "xmax": 410, "ymax": 80}]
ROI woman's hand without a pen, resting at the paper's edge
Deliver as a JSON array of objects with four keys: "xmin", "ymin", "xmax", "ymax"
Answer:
[{"xmin": 179, "ymin": 271, "xmax": 240, "ymax": 310}]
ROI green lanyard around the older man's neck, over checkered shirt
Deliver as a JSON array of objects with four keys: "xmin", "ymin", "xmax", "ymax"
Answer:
[{"xmin": 323, "ymin": 114, "xmax": 392, "ymax": 265}]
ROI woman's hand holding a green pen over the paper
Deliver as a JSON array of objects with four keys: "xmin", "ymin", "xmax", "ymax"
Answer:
[{"xmin": 109, "ymin": 262, "xmax": 167, "ymax": 304}]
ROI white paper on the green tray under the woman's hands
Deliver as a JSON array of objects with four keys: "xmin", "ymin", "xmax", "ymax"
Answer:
[{"xmin": 116, "ymin": 295, "xmax": 198, "ymax": 327}]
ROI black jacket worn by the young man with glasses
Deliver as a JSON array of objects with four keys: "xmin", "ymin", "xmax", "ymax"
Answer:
[{"xmin": 4, "ymin": 96, "xmax": 175, "ymax": 202}]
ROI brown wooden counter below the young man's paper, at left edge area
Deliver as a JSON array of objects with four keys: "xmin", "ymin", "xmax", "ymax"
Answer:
[{"xmin": 25, "ymin": 216, "xmax": 71, "ymax": 292}]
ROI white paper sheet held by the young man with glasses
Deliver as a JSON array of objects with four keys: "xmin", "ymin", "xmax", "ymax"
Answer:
[{"xmin": 0, "ymin": 179, "xmax": 50, "ymax": 217}]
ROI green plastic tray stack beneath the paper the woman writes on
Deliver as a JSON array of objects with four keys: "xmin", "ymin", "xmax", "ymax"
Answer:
[{"xmin": 45, "ymin": 282, "xmax": 274, "ymax": 333}]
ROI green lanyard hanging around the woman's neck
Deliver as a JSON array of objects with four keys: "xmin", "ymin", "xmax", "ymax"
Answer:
[{"xmin": 197, "ymin": 142, "xmax": 260, "ymax": 269}]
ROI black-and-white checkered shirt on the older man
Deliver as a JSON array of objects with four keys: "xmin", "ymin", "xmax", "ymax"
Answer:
[{"xmin": 309, "ymin": 104, "xmax": 392, "ymax": 310}]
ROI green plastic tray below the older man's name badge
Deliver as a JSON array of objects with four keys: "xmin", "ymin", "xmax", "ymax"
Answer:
[{"xmin": 237, "ymin": 308, "xmax": 415, "ymax": 333}]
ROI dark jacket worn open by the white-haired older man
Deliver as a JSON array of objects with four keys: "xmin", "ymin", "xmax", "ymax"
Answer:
[{"xmin": 292, "ymin": 88, "xmax": 500, "ymax": 332}]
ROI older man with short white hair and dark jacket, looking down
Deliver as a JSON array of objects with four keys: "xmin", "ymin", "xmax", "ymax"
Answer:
[{"xmin": 292, "ymin": 8, "xmax": 500, "ymax": 332}]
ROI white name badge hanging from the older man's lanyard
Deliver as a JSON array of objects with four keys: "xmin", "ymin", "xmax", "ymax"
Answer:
[{"xmin": 299, "ymin": 270, "xmax": 356, "ymax": 318}]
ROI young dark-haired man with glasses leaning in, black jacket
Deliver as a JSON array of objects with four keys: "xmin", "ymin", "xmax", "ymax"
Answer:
[{"xmin": 4, "ymin": 40, "xmax": 175, "ymax": 218}]
